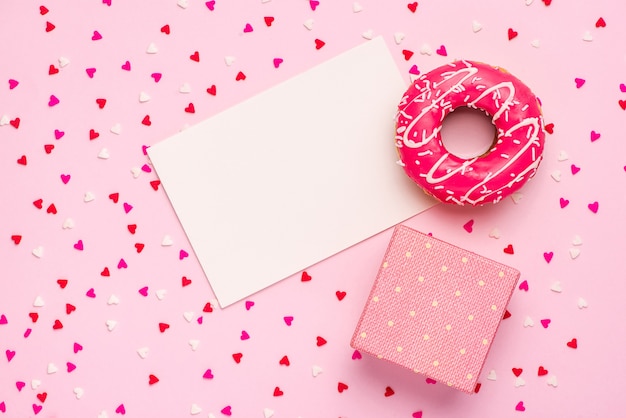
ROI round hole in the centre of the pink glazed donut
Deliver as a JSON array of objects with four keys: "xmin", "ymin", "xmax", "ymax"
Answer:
[{"xmin": 441, "ymin": 106, "xmax": 497, "ymax": 159}]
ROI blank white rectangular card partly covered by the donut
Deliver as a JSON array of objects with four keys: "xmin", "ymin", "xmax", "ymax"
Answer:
[{"xmin": 148, "ymin": 38, "xmax": 435, "ymax": 307}]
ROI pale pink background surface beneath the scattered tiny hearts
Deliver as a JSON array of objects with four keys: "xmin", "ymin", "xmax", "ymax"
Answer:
[{"xmin": 0, "ymin": 0, "xmax": 626, "ymax": 417}]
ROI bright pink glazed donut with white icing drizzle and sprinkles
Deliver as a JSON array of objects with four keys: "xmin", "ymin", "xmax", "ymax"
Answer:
[{"xmin": 395, "ymin": 61, "xmax": 545, "ymax": 205}]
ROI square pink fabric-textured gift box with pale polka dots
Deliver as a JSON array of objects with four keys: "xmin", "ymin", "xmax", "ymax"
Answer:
[{"xmin": 351, "ymin": 226, "xmax": 520, "ymax": 393}]
